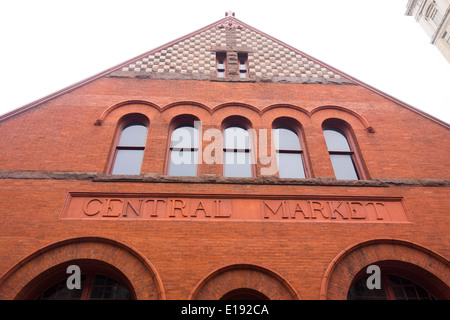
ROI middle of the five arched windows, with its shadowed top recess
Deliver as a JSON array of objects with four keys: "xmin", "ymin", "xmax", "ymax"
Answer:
[{"xmin": 223, "ymin": 116, "xmax": 255, "ymax": 178}]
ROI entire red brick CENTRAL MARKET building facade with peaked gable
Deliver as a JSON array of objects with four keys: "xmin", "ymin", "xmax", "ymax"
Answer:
[{"xmin": 0, "ymin": 16, "xmax": 450, "ymax": 300}]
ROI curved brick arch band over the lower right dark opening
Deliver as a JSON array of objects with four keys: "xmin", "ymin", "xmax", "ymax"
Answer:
[{"xmin": 320, "ymin": 239, "xmax": 450, "ymax": 300}]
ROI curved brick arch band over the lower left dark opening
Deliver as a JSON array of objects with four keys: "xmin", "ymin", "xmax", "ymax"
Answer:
[{"xmin": 0, "ymin": 237, "xmax": 165, "ymax": 300}]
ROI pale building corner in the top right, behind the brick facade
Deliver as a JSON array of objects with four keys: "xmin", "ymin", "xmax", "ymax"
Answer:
[{"xmin": 406, "ymin": 0, "xmax": 450, "ymax": 62}]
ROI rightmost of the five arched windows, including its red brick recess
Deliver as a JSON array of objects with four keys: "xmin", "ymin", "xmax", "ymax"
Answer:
[{"xmin": 322, "ymin": 119, "xmax": 367, "ymax": 180}]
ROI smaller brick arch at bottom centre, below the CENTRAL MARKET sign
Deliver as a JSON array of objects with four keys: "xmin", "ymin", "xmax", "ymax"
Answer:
[{"xmin": 188, "ymin": 264, "xmax": 300, "ymax": 300}]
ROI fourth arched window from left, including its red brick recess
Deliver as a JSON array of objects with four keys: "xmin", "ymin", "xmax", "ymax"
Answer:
[{"xmin": 272, "ymin": 118, "xmax": 310, "ymax": 178}]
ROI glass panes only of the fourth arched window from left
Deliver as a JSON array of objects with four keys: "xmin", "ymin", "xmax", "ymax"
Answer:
[{"xmin": 273, "ymin": 126, "xmax": 306, "ymax": 178}]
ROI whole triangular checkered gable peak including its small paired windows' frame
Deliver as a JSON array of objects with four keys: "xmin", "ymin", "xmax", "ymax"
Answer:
[{"xmin": 109, "ymin": 11, "xmax": 353, "ymax": 84}]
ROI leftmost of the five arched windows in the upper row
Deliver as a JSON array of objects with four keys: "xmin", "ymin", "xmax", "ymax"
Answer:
[{"xmin": 111, "ymin": 117, "xmax": 148, "ymax": 175}]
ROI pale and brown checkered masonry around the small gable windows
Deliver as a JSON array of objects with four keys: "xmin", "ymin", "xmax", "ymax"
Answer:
[{"xmin": 117, "ymin": 17, "xmax": 348, "ymax": 81}]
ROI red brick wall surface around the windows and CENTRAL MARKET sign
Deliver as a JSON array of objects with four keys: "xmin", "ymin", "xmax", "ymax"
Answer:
[{"xmin": 0, "ymin": 78, "xmax": 450, "ymax": 299}]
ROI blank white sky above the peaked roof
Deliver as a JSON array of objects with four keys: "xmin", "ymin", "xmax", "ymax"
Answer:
[{"xmin": 0, "ymin": 0, "xmax": 450, "ymax": 123}]
